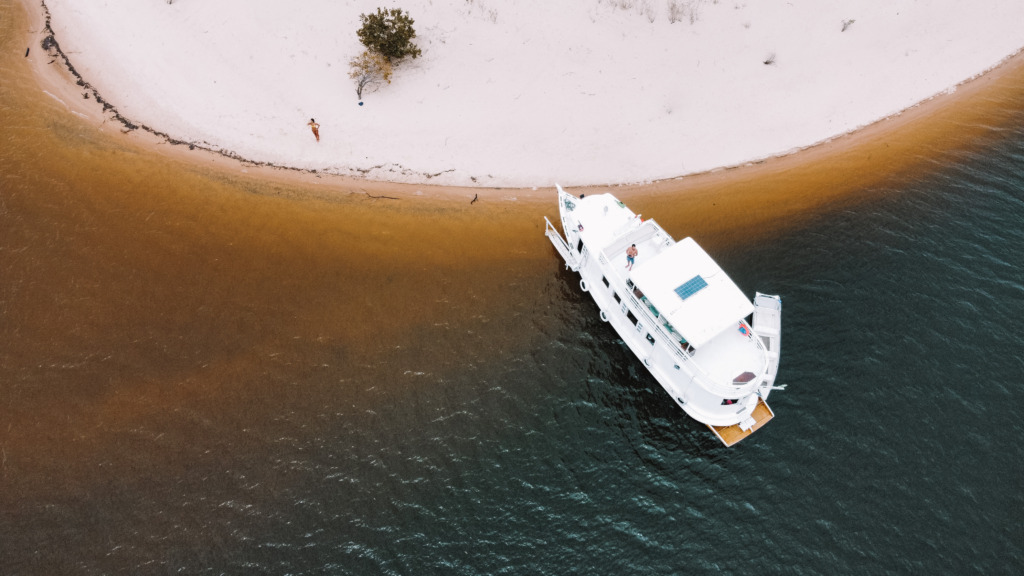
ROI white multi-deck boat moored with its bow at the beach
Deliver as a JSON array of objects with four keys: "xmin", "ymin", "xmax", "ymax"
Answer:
[{"xmin": 544, "ymin": 186, "xmax": 784, "ymax": 446}]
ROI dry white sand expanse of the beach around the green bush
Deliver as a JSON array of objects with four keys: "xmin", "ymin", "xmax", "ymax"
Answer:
[{"xmin": 39, "ymin": 0, "xmax": 1024, "ymax": 187}]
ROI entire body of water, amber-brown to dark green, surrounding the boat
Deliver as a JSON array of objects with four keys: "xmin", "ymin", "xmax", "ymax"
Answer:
[{"xmin": 0, "ymin": 1, "xmax": 1024, "ymax": 575}]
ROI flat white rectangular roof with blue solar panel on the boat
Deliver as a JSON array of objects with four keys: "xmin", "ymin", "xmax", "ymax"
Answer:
[{"xmin": 630, "ymin": 238, "xmax": 754, "ymax": 348}]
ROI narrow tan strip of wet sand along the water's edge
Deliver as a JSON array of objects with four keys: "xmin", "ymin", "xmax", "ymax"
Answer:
[{"xmin": 18, "ymin": 0, "xmax": 1024, "ymax": 203}]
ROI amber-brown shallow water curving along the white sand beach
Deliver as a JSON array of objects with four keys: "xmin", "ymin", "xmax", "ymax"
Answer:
[{"xmin": 6, "ymin": 1, "xmax": 1024, "ymax": 569}]
